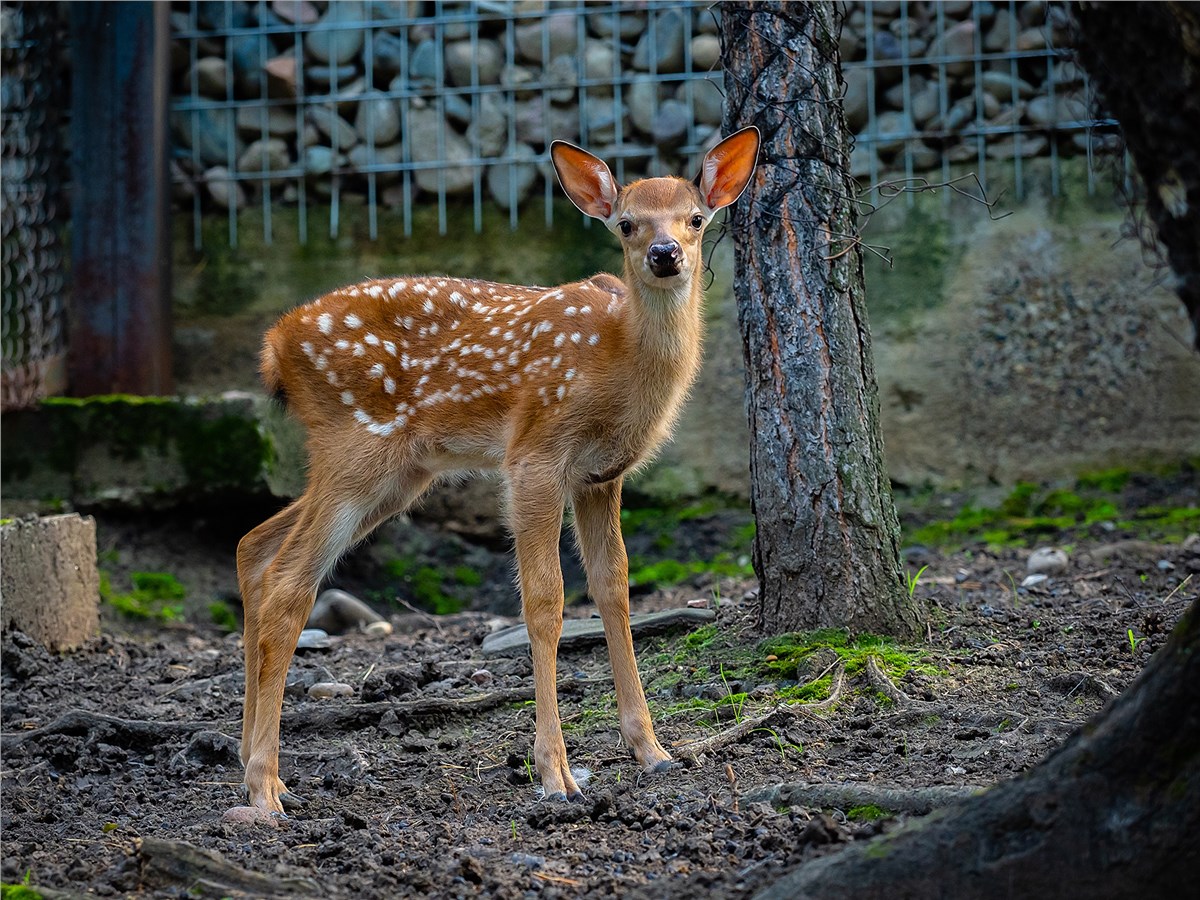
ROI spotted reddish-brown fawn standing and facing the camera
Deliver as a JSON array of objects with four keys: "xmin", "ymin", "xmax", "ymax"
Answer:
[{"xmin": 238, "ymin": 127, "xmax": 758, "ymax": 814}]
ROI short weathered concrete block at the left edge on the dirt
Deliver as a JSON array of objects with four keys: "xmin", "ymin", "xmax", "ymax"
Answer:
[{"xmin": 0, "ymin": 514, "xmax": 100, "ymax": 650}]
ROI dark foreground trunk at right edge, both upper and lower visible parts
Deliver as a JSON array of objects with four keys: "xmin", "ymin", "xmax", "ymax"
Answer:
[{"xmin": 756, "ymin": 14, "xmax": 1200, "ymax": 900}]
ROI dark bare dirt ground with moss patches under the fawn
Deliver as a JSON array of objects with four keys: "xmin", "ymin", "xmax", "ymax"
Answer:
[{"xmin": 0, "ymin": 496, "xmax": 1200, "ymax": 898}]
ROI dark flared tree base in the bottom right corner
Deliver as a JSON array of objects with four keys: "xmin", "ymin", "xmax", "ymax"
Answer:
[{"xmin": 755, "ymin": 604, "xmax": 1200, "ymax": 900}]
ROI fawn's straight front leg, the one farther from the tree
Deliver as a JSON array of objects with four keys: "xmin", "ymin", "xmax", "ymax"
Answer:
[{"xmin": 509, "ymin": 463, "xmax": 580, "ymax": 799}]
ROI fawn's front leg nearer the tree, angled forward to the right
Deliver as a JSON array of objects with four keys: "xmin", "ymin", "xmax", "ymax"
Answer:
[{"xmin": 572, "ymin": 478, "xmax": 671, "ymax": 769}]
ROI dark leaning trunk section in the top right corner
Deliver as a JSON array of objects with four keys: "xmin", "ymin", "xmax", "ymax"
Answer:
[{"xmin": 1075, "ymin": 2, "xmax": 1200, "ymax": 349}]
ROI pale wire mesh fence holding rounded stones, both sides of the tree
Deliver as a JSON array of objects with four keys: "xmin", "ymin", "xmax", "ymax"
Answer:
[{"xmin": 172, "ymin": 0, "xmax": 1112, "ymax": 254}]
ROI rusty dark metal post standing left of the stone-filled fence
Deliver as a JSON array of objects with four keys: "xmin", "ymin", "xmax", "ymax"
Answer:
[{"xmin": 68, "ymin": 2, "xmax": 173, "ymax": 396}]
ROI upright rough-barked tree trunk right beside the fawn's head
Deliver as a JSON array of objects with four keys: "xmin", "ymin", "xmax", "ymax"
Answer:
[{"xmin": 721, "ymin": 2, "xmax": 922, "ymax": 637}]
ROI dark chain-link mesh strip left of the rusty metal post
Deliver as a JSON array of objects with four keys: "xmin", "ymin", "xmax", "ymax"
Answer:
[{"xmin": 0, "ymin": 2, "xmax": 66, "ymax": 410}]
